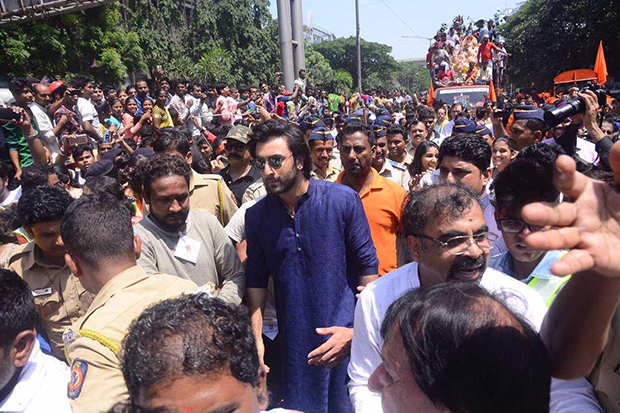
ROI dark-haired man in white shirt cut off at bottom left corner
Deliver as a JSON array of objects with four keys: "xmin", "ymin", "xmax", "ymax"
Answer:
[{"xmin": 0, "ymin": 270, "xmax": 71, "ymax": 413}]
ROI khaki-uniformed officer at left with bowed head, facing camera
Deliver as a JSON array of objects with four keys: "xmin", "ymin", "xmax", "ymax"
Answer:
[{"xmin": 6, "ymin": 186, "xmax": 94, "ymax": 360}]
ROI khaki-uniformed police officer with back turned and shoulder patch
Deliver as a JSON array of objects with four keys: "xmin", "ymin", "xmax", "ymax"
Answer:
[{"xmin": 61, "ymin": 194, "xmax": 196, "ymax": 413}]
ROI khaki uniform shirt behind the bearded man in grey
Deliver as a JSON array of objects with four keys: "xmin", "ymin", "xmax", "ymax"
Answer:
[{"xmin": 189, "ymin": 170, "xmax": 237, "ymax": 226}]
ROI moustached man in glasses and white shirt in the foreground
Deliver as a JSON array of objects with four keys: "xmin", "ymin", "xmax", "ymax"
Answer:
[{"xmin": 348, "ymin": 184, "xmax": 546, "ymax": 413}]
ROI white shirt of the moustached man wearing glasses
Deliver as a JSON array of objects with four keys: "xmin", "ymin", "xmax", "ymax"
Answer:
[{"xmin": 348, "ymin": 262, "xmax": 547, "ymax": 413}]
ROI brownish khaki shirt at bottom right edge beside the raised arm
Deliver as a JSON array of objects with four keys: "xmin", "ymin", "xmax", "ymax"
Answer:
[{"xmin": 588, "ymin": 305, "xmax": 620, "ymax": 413}]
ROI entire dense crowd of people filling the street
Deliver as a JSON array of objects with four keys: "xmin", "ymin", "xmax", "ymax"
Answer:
[{"xmin": 0, "ymin": 58, "xmax": 620, "ymax": 413}]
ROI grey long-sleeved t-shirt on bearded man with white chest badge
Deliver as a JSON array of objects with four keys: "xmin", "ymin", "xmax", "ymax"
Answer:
[{"xmin": 134, "ymin": 211, "xmax": 245, "ymax": 304}]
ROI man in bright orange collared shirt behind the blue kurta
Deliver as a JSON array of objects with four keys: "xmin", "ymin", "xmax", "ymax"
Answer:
[{"xmin": 336, "ymin": 123, "xmax": 407, "ymax": 276}]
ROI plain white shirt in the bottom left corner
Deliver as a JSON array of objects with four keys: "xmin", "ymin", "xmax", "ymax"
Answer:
[{"xmin": 0, "ymin": 340, "xmax": 71, "ymax": 413}]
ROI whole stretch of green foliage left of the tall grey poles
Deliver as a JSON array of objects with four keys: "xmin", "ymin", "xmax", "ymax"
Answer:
[{"xmin": 0, "ymin": 0, "xmax": 280, "ymax": 84}]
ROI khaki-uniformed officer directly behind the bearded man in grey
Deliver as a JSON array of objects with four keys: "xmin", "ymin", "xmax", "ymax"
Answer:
[{"xmin": 152, "ymin": 128, "xmax": 237, "ymax": 226}]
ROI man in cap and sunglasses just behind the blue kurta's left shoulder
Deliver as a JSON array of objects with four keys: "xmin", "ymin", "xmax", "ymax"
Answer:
[{"xmin": 219, "ymin": 125, "xmax": 260, "ymax": 205}]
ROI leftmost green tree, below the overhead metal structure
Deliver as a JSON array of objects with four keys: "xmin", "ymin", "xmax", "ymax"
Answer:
[{"xmin": 0, "ymin": 4, "xmax": 146, "ymax": 84}]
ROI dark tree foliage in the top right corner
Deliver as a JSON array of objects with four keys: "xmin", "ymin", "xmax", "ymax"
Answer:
[{"xmin": 500, "ymin": 0, "xmax": 620, "ymax": 89}]
